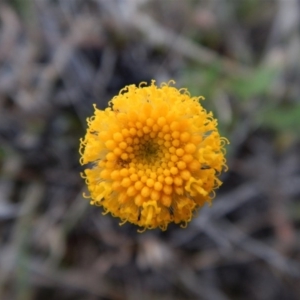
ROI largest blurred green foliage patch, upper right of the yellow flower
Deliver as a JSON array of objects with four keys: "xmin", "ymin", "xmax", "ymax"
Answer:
[{"xmin": 183, "ymin": 64, "xmax": 300, "ymax": 139}]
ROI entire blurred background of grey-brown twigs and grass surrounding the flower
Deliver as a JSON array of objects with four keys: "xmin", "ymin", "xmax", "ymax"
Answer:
[{"xmin": 0, "ymin": 0, "xmax": 300, "ymax": 300}]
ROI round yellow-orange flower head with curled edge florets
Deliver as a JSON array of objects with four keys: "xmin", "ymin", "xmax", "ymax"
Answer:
[{"xmin": 80, "ymin": 81, "xmax": 227, "ymax": 230}]
